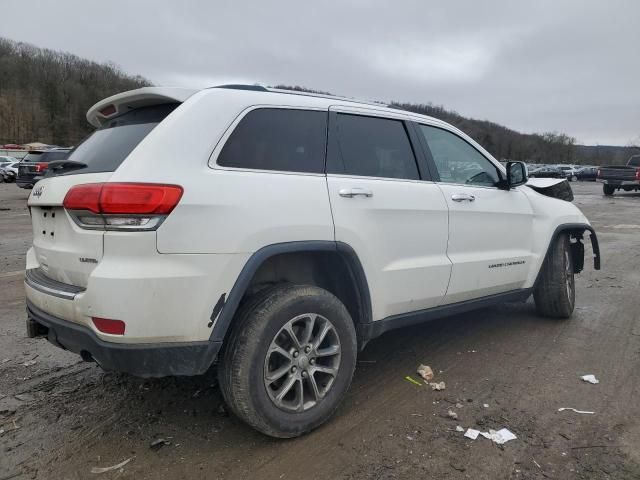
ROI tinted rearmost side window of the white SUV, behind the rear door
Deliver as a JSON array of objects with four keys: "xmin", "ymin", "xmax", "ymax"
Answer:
[{"xmin": 218, "ymin": 108, "xmax": 327, "ymax": 173}]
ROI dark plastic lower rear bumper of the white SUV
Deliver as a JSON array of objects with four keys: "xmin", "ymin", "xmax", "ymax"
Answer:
[{"xmin": 27, "ymin": 300, "xmax": 222, "ymax": 377}]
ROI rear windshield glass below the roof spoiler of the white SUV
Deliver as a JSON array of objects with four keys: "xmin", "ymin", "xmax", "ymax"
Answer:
[{"xmin": 57, "ymin": 103, "xmax": 179, "ymax": 175}]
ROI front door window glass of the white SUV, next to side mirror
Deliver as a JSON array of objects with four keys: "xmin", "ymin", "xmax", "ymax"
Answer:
[{"xmin": 420, "ymin": 125, "xmax": 500, "ymax": 187}]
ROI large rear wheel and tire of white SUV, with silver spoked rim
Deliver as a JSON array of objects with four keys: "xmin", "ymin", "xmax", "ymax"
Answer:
[{"xmin": 219, "ymin": 284, "xmax": 357, "ymax": 438}]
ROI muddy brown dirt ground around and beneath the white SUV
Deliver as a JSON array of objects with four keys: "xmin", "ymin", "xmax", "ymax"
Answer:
[{"xmin": 0, "ymin": 183, "xmax": 640, "ymax": 480}]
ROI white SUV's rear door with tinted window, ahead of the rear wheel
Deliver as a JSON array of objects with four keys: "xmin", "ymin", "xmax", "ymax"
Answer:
[{"xmin": 327, "ymin": 107, "xmax": 451, "ymax": 320}]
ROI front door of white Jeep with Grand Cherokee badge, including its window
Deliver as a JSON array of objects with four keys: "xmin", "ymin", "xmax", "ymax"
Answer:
[{"xmin": 418, "ymin": 125, "xmax": 534, "ymax": 304}]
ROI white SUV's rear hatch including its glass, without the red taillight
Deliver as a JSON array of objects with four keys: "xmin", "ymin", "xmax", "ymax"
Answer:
[{"xmin": 29, "ymin": 103, "xmax": 178, "ymax": 287}]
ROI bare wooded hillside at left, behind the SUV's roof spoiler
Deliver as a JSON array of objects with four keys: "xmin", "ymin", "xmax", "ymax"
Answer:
[{"xmin": 0, "ymin": 38, "xmax": 150, "ymax": 146}]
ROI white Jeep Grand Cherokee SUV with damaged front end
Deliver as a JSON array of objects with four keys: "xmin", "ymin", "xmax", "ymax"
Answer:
[{"xmin": 25, "ymin": 85, "xmax": 599, "ymax": 437}]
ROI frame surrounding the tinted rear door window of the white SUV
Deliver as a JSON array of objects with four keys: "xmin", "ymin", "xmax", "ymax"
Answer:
[{"xmin": 325, "ymin": 106, "xmax": 432, "ymax": 182}]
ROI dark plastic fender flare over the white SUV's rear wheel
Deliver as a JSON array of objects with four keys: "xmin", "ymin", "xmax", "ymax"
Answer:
[{"xmin": 209, "ymin": 240, "xmax": 372, "ymax": 342}]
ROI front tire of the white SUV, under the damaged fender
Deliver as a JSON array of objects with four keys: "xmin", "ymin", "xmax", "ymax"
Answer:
[{"xmin": 533, "ymin": 235, "xmax": 576, "ymax": 318}]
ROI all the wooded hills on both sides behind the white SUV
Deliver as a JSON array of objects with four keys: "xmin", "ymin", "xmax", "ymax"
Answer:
[{"xmin": 0, "ymin": 37, "xmax": 640, "ymax": 165}]
